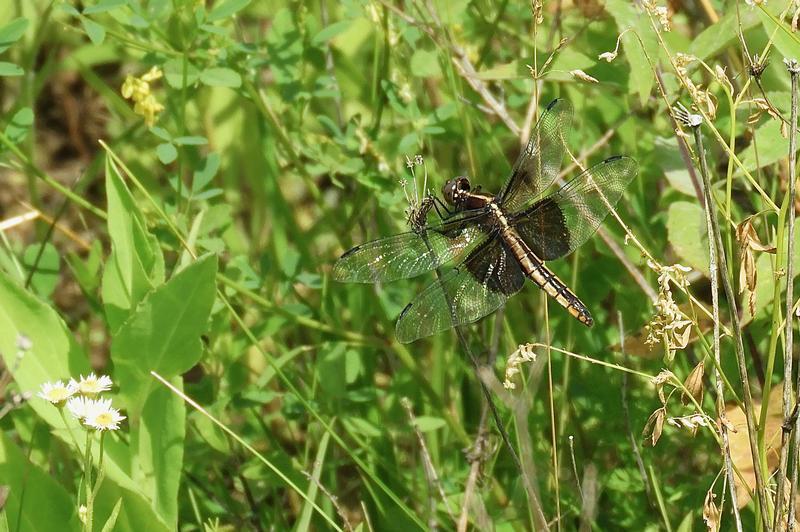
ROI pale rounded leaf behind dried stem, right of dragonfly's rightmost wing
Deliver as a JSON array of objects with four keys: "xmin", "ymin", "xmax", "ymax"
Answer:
[{"xmin": 667, "ymin": 201, "xmax": 709, "ymax": 276}]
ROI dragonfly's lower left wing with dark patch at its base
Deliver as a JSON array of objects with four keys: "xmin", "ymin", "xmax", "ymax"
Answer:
[{"xmin": 396, "ymin": 233, "xmax": 525, "ymax": 344}]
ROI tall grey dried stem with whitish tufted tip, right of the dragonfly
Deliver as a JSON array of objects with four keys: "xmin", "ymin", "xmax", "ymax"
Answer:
[{"xmin": 676, "ymin": 106, "xmax": 772, "ymax": 530}]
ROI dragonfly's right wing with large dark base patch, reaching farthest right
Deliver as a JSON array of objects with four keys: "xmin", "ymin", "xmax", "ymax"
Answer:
[{"xmin": 510, "ymin": 157, "xmax": 637, "ymax": 260}]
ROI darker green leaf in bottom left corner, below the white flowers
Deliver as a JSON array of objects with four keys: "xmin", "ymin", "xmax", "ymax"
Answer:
[{"xmin": 0, "ymin": 431, "xmax": 80, "ymax": 532}]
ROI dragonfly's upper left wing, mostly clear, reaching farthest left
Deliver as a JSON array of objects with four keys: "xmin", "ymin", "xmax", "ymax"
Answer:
[{"xmin": 333, "ymin": 209, "xmax": 488, "ymax": 283}]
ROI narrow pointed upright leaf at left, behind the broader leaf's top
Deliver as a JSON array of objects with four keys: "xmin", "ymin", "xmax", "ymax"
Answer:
[{"xmin": 102, "ymin": 157, "xmax": 164, "ymax": 332}]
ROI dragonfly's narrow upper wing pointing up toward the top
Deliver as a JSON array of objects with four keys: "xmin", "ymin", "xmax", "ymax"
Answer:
[{"xmin": 498, "ymin": 99, "xmax": 572, "ymax": 214}]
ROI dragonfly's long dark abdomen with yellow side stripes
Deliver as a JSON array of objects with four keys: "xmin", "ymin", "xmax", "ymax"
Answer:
[{"xmin": 502, "ymin": 227, "xmax": 594, "ymax": 327}]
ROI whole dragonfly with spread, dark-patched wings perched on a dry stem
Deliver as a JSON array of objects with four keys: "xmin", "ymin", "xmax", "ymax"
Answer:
[{"xmin": 332, "ymin": 99, "xmax": 637, "ymax": 343}]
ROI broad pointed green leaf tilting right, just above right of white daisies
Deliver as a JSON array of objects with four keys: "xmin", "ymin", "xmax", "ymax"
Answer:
[{"xmin": 111, "ymin": 255, "xmax": 217, "ymax": 416}]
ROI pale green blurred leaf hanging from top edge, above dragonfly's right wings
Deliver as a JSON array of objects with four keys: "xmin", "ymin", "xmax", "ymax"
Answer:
[{"xmin": 606, "ymin": 0, "xmax": 658, "ymax": 105}]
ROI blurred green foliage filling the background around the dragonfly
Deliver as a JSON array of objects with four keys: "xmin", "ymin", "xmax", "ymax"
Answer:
[{"xmin": 0, "ymin": 0, "xmax": 800, "ymax": 530}]
